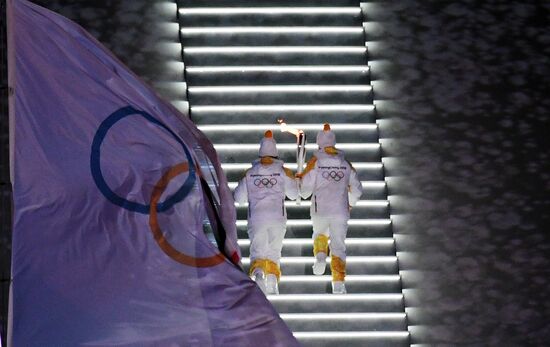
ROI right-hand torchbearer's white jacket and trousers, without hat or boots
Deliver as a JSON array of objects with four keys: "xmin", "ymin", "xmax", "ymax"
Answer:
[{"xmin": 300, "ymin": 150, "xmax": 363, "ymax": 262}]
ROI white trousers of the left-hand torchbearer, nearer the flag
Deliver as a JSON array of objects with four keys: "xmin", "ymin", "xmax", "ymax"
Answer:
[{"xmin": 248, "ymin": 221, "xmax": 286, "ymax": 264}]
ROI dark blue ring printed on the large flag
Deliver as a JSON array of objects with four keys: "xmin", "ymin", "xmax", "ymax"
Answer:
[{"xmin": 90, "ymin": 106, "xmax": 197, "ymax": 214}]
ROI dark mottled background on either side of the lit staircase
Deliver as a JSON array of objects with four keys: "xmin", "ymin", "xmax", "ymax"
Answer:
[{"xmin": 0, "ymin": 0, "xmax": 550, "ymax": 346}]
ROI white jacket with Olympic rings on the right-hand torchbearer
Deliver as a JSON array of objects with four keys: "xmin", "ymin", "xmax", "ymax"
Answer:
[{"xmin": 300, "ymin": 150, "xmax": 363, "ymax": 218}]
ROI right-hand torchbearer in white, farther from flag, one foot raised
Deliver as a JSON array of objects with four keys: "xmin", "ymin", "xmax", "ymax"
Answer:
[{"xmin": 297, "ymin": 123, "xmax": 363, "ymax": 294}]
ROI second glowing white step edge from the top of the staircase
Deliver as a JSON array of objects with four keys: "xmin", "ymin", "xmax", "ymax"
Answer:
[{"xmin": 181, "ymin": 26, "xmax": 363, "ymax": 35}]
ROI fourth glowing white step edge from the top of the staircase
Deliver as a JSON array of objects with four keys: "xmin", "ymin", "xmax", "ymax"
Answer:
[{"xmin": 186, "ymin": 65, "xmax": 369, "ymax": 74}]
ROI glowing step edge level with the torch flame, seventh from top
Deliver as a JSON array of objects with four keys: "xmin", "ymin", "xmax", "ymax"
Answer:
[{"xmin": 198, "ymin": 123, "xmax": 378, "ymax": 132}]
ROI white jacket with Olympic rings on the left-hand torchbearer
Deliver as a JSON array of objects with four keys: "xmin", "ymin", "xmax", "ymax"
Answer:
[{"xmin": 233, "ymin": 159, "xmax": 298, "ymax": 224}]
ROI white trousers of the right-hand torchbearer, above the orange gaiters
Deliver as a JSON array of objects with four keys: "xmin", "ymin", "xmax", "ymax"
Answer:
[{"xmin": 311, "ymin": 216, "xmax": 348, "ymax": 261}]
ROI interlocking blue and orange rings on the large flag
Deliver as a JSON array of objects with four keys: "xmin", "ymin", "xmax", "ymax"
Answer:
[{"xmin": 90, "ymin": 106, "xmax": 225, "ymax": 267}]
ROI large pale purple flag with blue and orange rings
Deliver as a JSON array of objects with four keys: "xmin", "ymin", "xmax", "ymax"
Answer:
[{"xmin": 8, "ymin": 0, "xmax": 298, "ymax": 347}]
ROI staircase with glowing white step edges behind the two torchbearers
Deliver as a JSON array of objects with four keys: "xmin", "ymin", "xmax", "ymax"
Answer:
[{"xmin": 178, "ymin": 0, "xmax": 409, "ymax": 347}]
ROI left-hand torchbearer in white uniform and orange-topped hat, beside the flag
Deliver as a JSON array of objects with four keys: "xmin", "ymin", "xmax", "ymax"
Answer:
[{"xmin": 234, "ymin": 130, "xmax": 298, "ymax": 294}]
